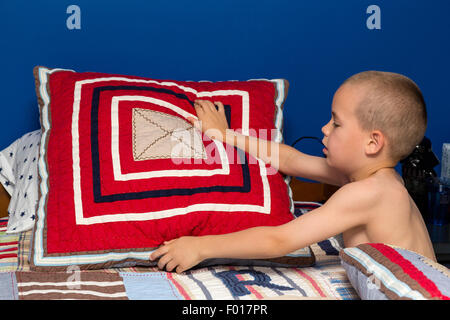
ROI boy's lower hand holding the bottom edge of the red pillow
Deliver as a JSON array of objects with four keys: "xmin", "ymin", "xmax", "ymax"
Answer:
[{"xmin": 150, "ymin": 237, "xmax": 203, "ymax": 273}]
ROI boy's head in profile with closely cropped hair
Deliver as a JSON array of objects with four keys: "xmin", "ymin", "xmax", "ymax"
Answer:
[{"xmin": 322, "ymin": 71, "xmax": 427, "ymax": 175}]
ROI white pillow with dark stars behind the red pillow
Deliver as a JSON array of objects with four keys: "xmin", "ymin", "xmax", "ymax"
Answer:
[{"xmin": 0, "ymin": 129, "xmax": 41, "ymax": 233}]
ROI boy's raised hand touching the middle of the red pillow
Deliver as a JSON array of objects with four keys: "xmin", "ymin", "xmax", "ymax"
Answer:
[{"xmin": 187, "ymin": 100, "xmax": 228, "ymax": 141}]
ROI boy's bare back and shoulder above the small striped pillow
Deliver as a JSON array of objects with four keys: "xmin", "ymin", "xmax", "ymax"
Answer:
[{"xmin": 342, "ymin": 169, "xmax": 436, "ymax": 261}]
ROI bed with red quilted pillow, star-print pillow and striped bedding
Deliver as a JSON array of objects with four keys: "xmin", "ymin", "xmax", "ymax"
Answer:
[{"xmin": 0, "ymin": 66, "xmax": 450, "ymax": 300}]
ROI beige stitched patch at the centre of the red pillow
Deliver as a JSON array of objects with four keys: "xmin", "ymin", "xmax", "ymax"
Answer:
[{"xmin": 132, "ymin": 108, "xmax": 206, "ymax": 161}]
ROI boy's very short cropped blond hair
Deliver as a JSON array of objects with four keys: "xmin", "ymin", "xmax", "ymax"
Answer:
[{"xmin": 342, "ymin": 71, "xmax": 427, "ymax": 162}]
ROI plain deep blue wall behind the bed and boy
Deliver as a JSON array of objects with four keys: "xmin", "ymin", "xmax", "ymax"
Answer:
[{"xmin": 0, "ymin": 0, "xmax": 450, "ymax": 173}]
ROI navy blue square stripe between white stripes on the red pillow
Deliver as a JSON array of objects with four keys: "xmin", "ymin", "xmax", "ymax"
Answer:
[{"xmin": 87, "ymin": 86, "xmax": 251, "ymax": 203}]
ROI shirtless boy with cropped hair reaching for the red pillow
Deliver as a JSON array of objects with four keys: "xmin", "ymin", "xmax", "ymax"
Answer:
[{"xmin": 150, "ymin": 71, "xmax": 436, "ymax": 273}]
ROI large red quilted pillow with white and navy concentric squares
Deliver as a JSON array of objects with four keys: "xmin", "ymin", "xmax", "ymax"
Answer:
[{"xmin": 31, "ymin": 67, "xmax": 293, "ymax": 269}]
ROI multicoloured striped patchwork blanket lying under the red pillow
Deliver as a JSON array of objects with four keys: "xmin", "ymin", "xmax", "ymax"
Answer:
[{"xmin": 0, "ymin": 202, "xmax": 359, "ymax": 300}]
